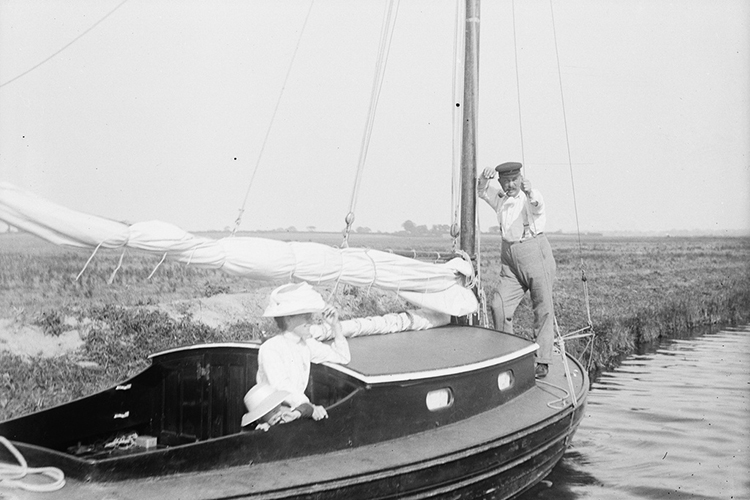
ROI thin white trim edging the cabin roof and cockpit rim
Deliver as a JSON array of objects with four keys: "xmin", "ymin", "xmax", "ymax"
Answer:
[{"xmin": 148, "ymin": 342, "xmax": 539, "ymax": 385}]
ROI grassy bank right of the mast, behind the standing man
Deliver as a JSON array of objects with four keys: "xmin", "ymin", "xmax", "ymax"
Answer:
[{"xmin": 483, "ymin": 237, "xmax": 750, "ymax": 371}]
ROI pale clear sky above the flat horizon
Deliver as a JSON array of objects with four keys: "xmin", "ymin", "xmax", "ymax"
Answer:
[{"xmin": 0, "ymin": 0, "xmax": 750, "ymax": 233}]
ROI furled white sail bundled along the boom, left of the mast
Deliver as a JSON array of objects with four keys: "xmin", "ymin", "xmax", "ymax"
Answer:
[{"xmin": 0, "ymin": 183, "xmax": 478, "ymax": 316}]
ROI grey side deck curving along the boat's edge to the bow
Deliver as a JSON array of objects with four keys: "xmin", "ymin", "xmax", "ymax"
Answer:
[{"xmin": 8, "ymin": 356, "xmax": 588, "ymax": 500}]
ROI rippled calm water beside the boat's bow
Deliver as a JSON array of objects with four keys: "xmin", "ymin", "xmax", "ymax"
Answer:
[{"xmin": 522, "ymin": 326, "xmax": 750, "ymax": 500}]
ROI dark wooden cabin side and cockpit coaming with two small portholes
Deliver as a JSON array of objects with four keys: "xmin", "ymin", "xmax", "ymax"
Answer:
[{"xmin": 0, "ymin": 334, "xmax": 533, "ymax": 481}]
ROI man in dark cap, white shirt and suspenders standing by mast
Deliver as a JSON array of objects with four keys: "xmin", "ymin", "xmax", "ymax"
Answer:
[{"xmin": 478, "ymin": 162, "xmax": 556, "ymax": 378}]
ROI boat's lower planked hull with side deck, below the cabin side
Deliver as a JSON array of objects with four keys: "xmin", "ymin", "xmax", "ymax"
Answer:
[{"xmin": 4, "ymin": 364, "xmax": 585, "ymax": 500}]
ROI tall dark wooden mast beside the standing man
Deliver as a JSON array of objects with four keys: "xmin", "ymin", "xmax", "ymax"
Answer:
[{"xmin": 459, "ymin": 0, "xmax": 480, "ymax": 268}]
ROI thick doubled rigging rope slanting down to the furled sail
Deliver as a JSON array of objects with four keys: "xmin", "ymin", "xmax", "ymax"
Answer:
[{"xmin": 341, "ymin": 0, "xmax": 399, "ymax": 247}]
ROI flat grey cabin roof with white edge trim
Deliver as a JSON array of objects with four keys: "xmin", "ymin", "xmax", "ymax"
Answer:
[{"xmin": 149, "ymin": 325, "xmax": 539, "ymax": 384}]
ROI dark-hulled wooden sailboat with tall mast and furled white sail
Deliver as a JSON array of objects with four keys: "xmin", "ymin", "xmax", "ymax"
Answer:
[{"xmin": 0, "ymin": 0, "xmax": 589, "ymax": 500}]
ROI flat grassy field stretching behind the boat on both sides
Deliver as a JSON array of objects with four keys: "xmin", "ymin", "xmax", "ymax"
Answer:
[{"xmin": 0, "ymin": 233, "xmax": 750, "ymax": 420}]
